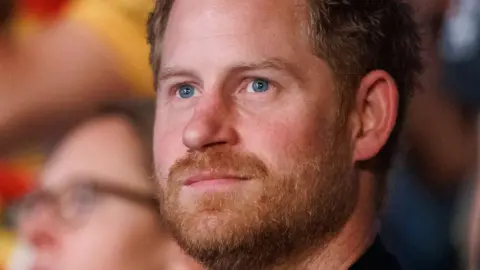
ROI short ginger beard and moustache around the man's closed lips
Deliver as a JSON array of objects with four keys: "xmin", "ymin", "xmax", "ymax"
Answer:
[{"xmin": 159, "ymin": 121, "xmax": 358, "ymax": 270}]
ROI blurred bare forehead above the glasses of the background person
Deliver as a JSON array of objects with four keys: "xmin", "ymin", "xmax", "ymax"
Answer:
[{"xmin": 40, "ymin": 116, "xmax": 149, "ymax": 191}]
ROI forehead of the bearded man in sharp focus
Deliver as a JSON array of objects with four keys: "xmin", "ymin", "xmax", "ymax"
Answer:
[{"xmin": 162, "ymin": 0, "xmax": 310, "ymax": 70}]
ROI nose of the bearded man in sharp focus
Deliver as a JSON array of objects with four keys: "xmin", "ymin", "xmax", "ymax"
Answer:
[{"xmin": 183, "ymin": 94, "xmax": 238, "ymax": 150}]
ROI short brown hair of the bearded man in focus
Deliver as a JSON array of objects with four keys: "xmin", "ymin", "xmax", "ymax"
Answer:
[{"xmin": 148, "ymin": 0, "xmax": 423, "ymax": 175}]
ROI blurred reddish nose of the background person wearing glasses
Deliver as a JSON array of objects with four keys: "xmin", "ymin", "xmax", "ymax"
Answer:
[{"xmin": 19, "ymin": 207, "xmax": 60, "ymax": 250}]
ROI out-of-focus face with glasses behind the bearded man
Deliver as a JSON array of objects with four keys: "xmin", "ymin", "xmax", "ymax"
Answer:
[{"xmin": 16, "ymin": 116, "xmax": 201, "ymax": 270}]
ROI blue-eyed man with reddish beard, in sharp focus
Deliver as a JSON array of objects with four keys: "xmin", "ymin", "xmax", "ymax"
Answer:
[{"xmin": 149, "ymin": 0, "xmax": 422, "ymax": 270}]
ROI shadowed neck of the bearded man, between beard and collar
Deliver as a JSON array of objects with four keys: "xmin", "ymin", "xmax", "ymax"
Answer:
[{"xmin": 278, "ymin": 172, "xmax": 378, "ymax": 270}]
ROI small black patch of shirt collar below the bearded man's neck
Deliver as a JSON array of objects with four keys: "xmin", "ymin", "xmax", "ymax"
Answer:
[{"xmin": 350, "ymin": 237, "xmax": 402, "ymax": 270}]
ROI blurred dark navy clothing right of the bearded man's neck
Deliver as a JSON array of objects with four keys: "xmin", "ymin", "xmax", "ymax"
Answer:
[{"xmin": 380, "ymin": 158, "xmax": 459, "ymax": 270}]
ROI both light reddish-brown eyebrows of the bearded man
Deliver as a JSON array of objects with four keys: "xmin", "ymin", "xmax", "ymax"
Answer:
[{"xmin": 158, "ymin": 58, "xmax": 303, "ymax": 85}]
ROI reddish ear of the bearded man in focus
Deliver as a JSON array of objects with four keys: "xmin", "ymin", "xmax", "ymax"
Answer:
[{"xmin": 352, "ymin": 70, "xmax": 398, "ymax": 161}]
